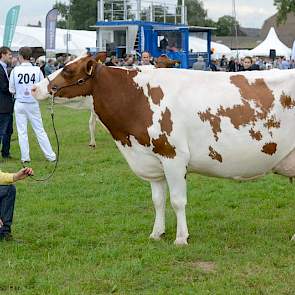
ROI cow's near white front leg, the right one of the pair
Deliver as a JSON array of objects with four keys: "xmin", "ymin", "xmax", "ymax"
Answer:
[{"xmin": 164, "ymin": 159, "xmax": 189, "ymax": 245}]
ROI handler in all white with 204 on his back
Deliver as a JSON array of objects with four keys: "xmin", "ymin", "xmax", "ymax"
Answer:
[{"xmin": 9, "ymin": 47, "xmax": 56, "ymax": 163}]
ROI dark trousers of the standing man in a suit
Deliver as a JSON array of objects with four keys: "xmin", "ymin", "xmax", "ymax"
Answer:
[{"xmin": 0, "ymin": 113, "xmax": 13, "ymax": 158}]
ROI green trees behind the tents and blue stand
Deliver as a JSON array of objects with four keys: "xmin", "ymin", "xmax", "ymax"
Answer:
[{"xmin": 54, "ymin": 0, "xmax": 295, "ymax": 36}]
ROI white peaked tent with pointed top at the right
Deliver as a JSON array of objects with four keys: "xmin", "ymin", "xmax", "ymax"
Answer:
[{"xmin": 249, "ymin": 27, "xmax": 291, "ymax": 58}]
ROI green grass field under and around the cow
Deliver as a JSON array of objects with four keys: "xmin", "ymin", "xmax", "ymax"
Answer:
[{"xmin": 0, "ymin": 104, "xmax": 295, "ymax": 295}]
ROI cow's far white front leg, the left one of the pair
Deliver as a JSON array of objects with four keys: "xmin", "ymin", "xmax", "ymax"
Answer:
[{"xmin": 150, "ymin": 180, "xmax": 166, "ymax": 240}]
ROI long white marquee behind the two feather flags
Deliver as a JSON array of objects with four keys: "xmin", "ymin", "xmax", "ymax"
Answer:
[{"xmin": 0, "ymin": 25, "xmax": 96, "ymax": 55}]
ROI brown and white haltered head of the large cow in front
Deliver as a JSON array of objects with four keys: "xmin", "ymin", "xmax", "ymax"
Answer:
[{"xmin": 32, "ymin": 53, "xmax": 103, "ymax": 100}]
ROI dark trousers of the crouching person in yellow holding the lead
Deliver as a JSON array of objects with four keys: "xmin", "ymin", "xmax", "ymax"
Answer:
[{"xmin": 0, "ymin": 184, "xmax": 16, "ymax": 236}]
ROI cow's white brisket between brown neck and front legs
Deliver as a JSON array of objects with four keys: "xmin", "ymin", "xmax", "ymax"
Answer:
[{"xmin": 116, "ymin": 139, "xmax": 165, "ymax": 181}]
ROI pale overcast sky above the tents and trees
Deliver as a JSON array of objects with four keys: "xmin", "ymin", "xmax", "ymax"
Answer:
[{"xmin": 0, "ymin": 0, "xmax": 276, "ymax": 28}]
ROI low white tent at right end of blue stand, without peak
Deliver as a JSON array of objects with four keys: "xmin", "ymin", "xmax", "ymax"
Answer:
[{"xmin": 189, "ymin": 36, "xmax": 231, "ymax": 58}]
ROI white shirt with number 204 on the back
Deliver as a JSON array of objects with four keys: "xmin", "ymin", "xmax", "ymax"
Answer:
[{"xmin": 9, "ymin": 62, "xmax": 44, "ymax": 103}]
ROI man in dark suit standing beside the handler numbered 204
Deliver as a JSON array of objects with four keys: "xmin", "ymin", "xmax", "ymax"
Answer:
[{"xmin": 0, "ymin": 47, "xmax": 14, "ymax": 159}]
